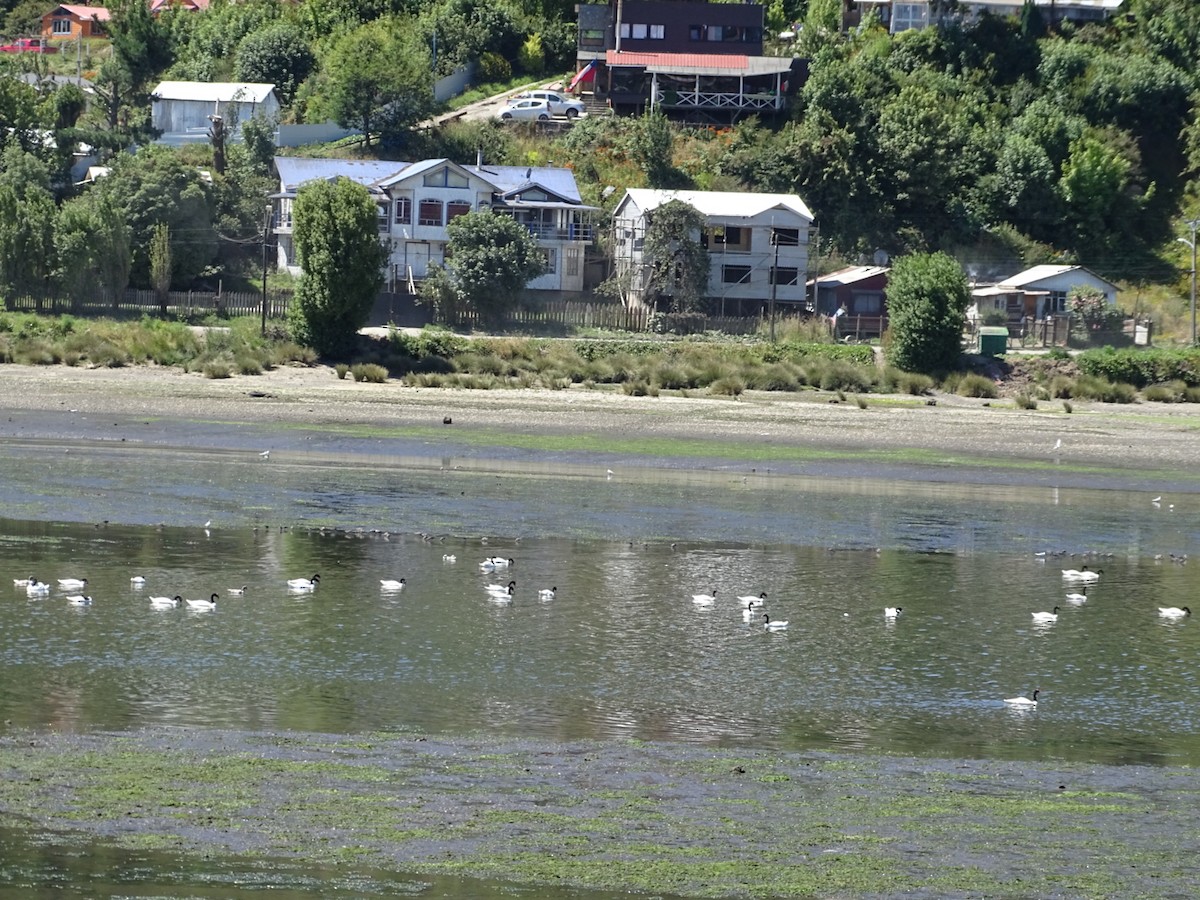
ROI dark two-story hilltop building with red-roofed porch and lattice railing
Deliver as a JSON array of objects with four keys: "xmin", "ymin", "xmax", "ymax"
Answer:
[{"xmin": 571, "ymin": 0, "xmax": 805, "ymax": 121}]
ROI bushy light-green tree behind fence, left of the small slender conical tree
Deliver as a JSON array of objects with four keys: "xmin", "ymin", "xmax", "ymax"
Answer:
[{"xmin": 54, "ymin": 191, "xmax": 131, "ymax": 305}]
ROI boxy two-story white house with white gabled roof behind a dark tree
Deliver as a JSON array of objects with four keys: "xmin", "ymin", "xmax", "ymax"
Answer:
[{"xmin": 613, "ymin": 187, "xmax": 812, "ymax": 305}]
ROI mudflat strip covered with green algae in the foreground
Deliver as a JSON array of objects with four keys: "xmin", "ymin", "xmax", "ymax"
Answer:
[{"xmin": 0, "ymin": 730, "xmax": 1200, "ymax": 896}]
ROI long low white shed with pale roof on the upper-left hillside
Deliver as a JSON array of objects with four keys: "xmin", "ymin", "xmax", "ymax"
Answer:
[{"xmin": 150, "ymin": 82, "xmax": 280, "ymax": 144}]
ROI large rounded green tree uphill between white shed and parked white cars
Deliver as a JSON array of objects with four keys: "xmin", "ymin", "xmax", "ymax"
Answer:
[{"xmin": 310, "ymin": 19, "xmax": 434, "ymax": 146}]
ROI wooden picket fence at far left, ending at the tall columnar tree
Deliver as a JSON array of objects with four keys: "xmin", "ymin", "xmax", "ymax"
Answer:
[{"xmin": 5, "ymin": 288, "xmax": 292, "ymax": 319}]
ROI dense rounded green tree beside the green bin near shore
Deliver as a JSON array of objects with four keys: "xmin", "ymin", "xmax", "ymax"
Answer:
[{"xmin": 888, "ymin": 253, "xmax": 971, "ymax": 372}]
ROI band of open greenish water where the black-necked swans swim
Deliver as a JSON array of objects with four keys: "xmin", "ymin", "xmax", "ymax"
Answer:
[{"xmin": 0, "ymin": 513, "xmax": 1200, "ymax": 764}]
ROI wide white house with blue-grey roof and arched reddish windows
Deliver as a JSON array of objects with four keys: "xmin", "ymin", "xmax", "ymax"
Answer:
[{"xmin": 274, "ymin": 156, "xmax": 595, "ymax": 293}]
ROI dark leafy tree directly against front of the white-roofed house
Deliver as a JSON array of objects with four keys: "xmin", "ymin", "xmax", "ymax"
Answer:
[{"xmin": 642, "ymin": 200, "xmax": 708, "ymax": 312}]
